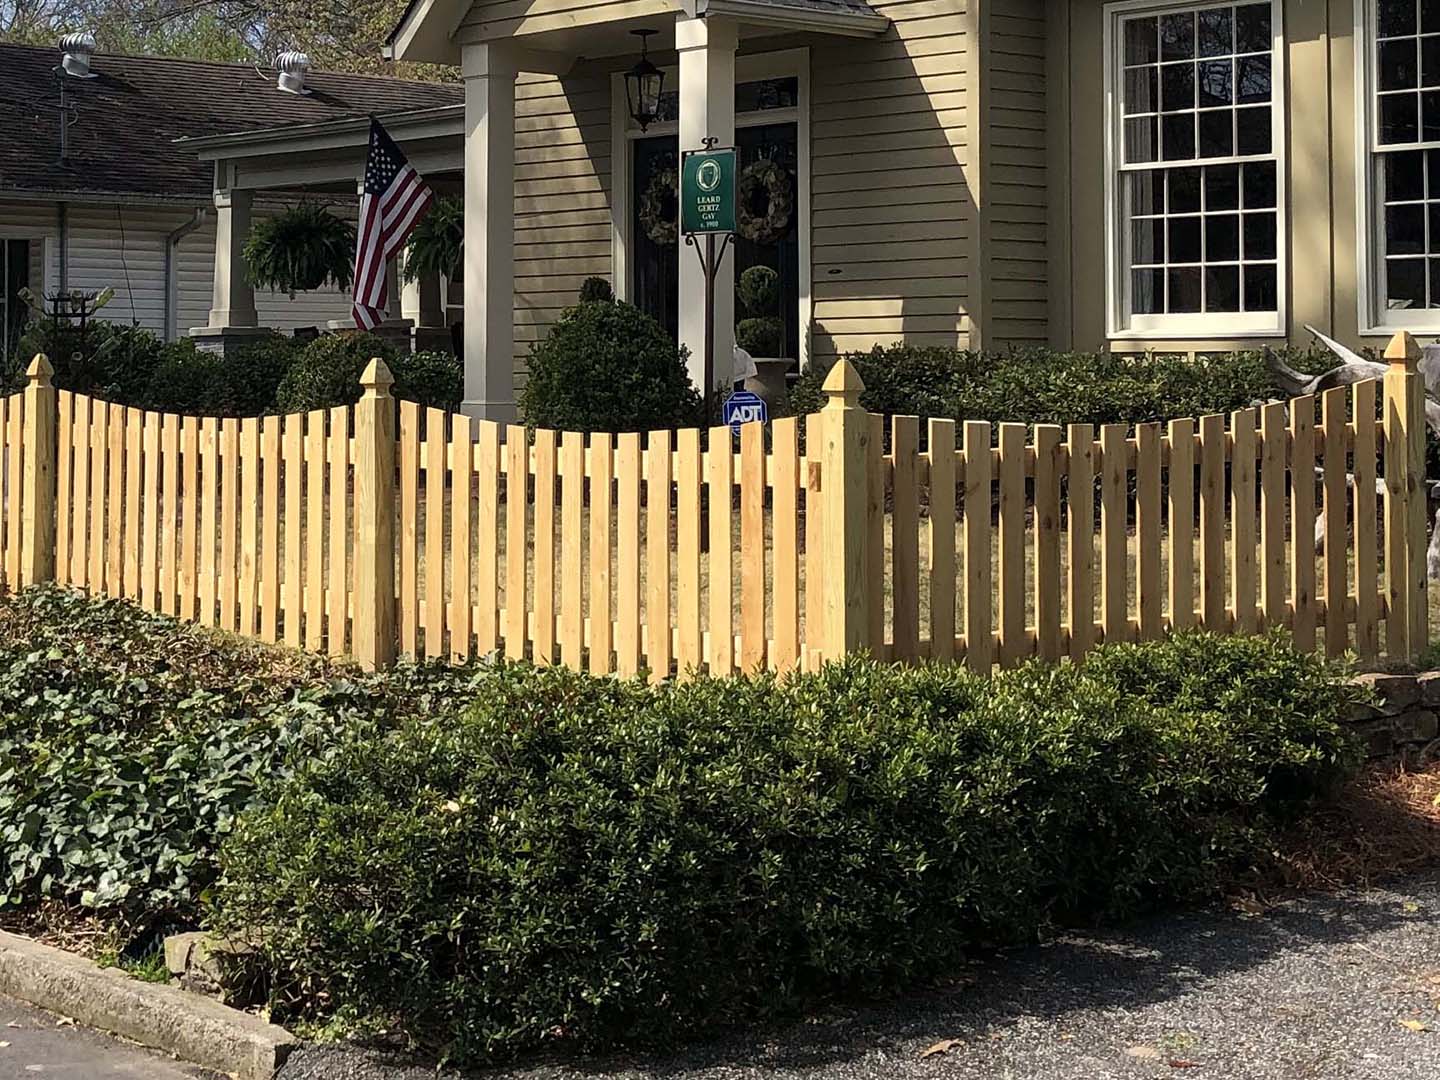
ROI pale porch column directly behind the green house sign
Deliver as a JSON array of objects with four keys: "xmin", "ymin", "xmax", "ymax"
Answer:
[{"xmin": 675, "ymin": 16, "xmax": 737, "ymax": 389}]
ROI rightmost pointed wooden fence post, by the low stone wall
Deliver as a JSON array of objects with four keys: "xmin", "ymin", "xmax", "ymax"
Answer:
[{"xmin": 1384, "ymin": 331, "xmax": 1430, "ymax": 660}]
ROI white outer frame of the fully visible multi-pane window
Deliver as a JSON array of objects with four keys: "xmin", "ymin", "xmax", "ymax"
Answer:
[{"xmin": 1103, "ymin": 0, "xmax": 1290, "ymax": 340}]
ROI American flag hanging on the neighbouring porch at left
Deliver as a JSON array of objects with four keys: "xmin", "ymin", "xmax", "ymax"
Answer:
[{"xmin": 351, "ymin": 117, "xmax": 435, "ymax": 330}]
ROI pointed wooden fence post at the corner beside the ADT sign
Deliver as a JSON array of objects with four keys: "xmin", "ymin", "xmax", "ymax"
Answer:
[{"xmin": 806, "ymin": 360, "xmax": 884, "ymax": 661}]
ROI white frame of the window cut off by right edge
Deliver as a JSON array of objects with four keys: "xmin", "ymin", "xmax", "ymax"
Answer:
[{"xmin": 1354, "ymin": 0, "xmax": 1440, "ymax": 334}]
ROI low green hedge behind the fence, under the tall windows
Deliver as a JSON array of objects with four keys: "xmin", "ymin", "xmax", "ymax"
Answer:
[{"xmin": 791, "ymin": 346, "xmax": 1335, "ymax": 423}]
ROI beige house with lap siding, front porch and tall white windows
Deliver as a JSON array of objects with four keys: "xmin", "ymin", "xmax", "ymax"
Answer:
[{"xmin": 174, "ymin": 0, "xmax": 1440, "ymax": 416}]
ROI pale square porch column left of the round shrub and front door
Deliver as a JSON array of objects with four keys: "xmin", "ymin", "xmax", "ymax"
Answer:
[{"xmin": 461, "ymin": 45, "xmax": 517, "ymax": 420}]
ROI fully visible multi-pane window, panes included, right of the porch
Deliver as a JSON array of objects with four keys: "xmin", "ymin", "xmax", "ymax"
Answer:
[{"xmin": 1107, "ymin": 0, "xmax": 1282, "ymax": 336}]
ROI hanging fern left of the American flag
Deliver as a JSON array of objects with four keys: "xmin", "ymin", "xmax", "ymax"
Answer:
[{"xmin": 242, "ymin": 203, "xmax": 356, "ymax": 300}]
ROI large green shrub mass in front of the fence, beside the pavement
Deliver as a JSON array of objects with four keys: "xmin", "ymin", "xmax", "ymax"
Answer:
[{"xmin": 213, "ymin": 634, "xmax": 1356, "ymax": 1061}]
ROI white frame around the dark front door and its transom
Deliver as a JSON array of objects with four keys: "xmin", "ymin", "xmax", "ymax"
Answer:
[{"xmin": 611, "ymin": 48, "xmax": 814, "ymax": 372}]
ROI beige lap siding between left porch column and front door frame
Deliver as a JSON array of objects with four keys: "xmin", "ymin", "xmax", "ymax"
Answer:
[{"xmin": 516, "ymin": 66, "xmax": 611, "ymax": 377}]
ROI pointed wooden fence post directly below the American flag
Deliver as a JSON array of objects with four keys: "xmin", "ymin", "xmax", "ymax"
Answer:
[{"xmin": 351, "ymin": 357, "xmax": 395, "ymax": 671}]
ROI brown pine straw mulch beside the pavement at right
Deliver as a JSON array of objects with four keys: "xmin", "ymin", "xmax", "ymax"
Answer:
[{"xmin": 1228, "ymin": 760, "xmax": 1440, "ymax": 912}]
